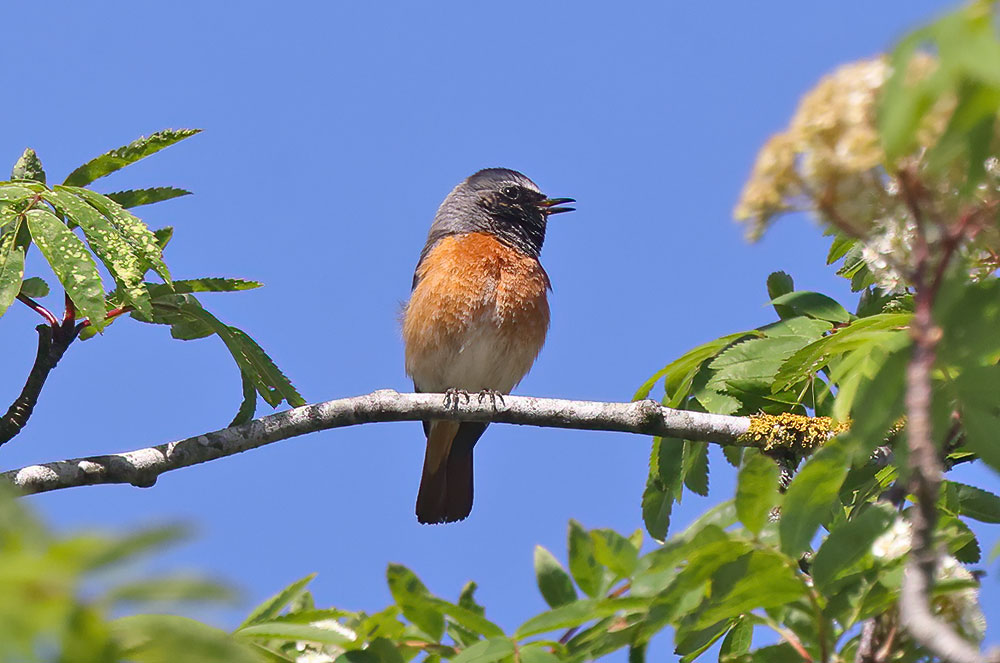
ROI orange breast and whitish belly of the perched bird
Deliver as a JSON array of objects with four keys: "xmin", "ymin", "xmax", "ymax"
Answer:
[{"xmin": 403, "ymin": 233, "xmax": 549, "ymax": 393}]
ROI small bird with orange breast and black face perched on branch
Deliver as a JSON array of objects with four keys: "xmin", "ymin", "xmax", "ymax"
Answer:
[{"xmin": 402, "ymin": 168, "xmax": 576, "ymax": 524}]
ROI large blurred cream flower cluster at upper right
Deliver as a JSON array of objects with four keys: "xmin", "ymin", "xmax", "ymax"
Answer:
[{"xmin": 735, "ymin": 54, "xmax": 1000, "ymax": 291}]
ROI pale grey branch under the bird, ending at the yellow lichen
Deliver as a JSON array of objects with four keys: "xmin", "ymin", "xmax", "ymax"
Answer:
[{"xmin": 0, "ymin": 389, "xmax": 758, "ymax": 494}]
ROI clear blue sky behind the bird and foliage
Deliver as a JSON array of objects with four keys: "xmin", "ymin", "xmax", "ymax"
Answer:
[{"xmin": 0, "ymin": 0, "xmax": 1000, "ymax": 656}]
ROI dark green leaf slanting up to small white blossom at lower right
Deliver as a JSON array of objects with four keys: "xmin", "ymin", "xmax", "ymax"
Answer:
[{"xmin": 812, "ymin": 504, "xmax": 896, "ymax": 590}]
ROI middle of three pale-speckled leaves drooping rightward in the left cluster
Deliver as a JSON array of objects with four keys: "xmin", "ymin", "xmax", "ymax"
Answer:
[{"xmin": 42, "ymin": 188, "xmax": 153, "ymax": 318}]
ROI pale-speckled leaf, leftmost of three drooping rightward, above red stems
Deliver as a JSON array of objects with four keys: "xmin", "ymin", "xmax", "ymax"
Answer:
[{"xmin": 25, "ymin": 209, "xmax": 107, "ymax": 331}]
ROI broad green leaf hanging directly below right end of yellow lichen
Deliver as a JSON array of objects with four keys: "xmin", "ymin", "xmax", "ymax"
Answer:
[{"xmin": 778, "ymin": 440, "xmax": 848, "ymax": 557}]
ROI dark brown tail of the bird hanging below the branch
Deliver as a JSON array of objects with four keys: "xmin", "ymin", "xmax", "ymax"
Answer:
[{"xmin": 417, "ymin": 421, "xmax": 486, "ymax": 523}]
